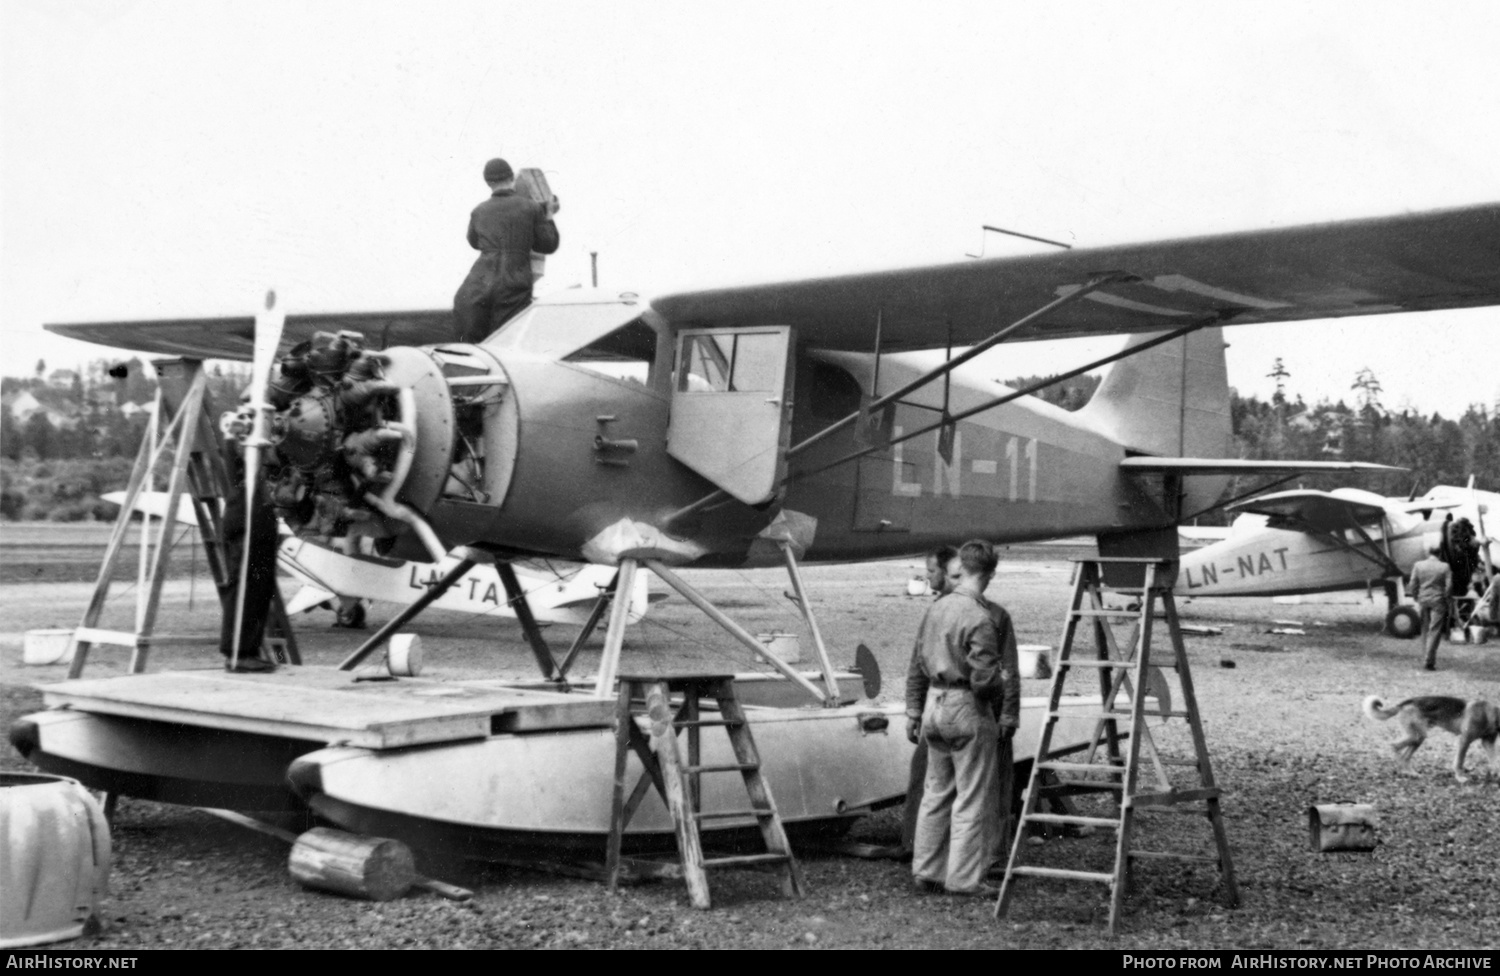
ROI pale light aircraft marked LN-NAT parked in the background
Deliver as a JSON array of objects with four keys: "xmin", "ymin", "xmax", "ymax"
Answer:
[{"xmin": 1178, "ymin": 484, "xmax": 1500, "ymax": 637}]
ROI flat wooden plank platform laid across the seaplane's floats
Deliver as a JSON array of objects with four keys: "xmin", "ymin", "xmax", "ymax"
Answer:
[{"xmin": 39, "ymin": 667, "xmax": 615, "ymax": 750}]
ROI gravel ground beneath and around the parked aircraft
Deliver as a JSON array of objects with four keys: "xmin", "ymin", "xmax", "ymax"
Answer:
[{"xmin": 0, "ymin": 547, "xmax": 1500, "ymax": 951}]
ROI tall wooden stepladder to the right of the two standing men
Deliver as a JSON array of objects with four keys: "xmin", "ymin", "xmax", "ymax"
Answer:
[{"xmin": 995, "ymin": 558, "xmax": 1239, "ymax": 936}]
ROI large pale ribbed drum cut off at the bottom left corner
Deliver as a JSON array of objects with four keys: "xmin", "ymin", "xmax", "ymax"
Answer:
[{"xmin": 0, "ymin": 772, "xmax": 110, "ymax": 949}]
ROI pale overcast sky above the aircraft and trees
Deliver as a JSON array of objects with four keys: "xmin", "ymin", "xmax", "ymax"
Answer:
[{"xmin": 0, "ymin": 0, "xmax": 1500, "ymax": 415}]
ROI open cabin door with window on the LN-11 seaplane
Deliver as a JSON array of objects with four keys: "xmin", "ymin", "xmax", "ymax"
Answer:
[{"xmin": 668, "ymin": 325, "xmax": 792, "ymax": 505}]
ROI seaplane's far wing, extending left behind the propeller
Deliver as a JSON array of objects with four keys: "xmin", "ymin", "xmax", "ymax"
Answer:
[{"xmin": 47, "ymin": 309, "xmax": 453, "ymax": 361}]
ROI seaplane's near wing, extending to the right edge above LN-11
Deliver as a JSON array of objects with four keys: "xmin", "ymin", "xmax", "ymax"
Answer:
[{"xmin": 651, "ymin": 204, "xmax": 1500, "ymax": 351}]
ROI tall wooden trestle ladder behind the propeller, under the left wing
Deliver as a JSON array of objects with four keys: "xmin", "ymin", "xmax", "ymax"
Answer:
[{"xmin": 68, "ymin": 360, "xmax": 302, "ymax": 678}]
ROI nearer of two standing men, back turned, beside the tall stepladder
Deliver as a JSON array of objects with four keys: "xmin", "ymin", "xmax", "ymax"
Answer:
[{"xmin": 906, "ymin": 540, "xmax": 1001, "ymax": 895}]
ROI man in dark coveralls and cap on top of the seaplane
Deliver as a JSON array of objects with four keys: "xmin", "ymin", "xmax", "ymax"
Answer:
[{"xmin": 453, "ymin": 159, "xmax": 560, "ymax": 342}]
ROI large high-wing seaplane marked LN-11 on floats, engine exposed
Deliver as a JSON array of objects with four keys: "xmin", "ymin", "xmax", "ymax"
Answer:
[{"xmin": 12, "ymin": 204, "xmax": 1500, "ymax": 853}]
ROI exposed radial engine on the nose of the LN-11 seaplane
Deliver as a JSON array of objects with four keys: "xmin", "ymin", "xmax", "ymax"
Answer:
[{"xmin": 266, "ymin": 333, "xmax": 516, "ymax": 561}]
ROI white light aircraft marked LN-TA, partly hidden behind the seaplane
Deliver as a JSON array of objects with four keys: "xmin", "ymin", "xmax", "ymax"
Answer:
[{"xmin": 102, "ymin": 492, "xmax": 651, "ymax": 627}]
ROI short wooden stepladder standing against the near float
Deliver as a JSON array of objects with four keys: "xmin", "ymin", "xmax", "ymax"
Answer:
[{"xmin": 605, "ymin": 675, "xmax": 804, "ymax": 909}]
